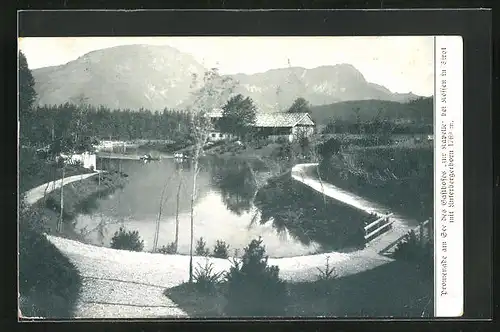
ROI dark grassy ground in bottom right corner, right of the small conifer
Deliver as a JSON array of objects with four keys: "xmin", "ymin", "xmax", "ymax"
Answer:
[{"xmin": 288, "ymin": 261, "xmax": 434, "ymax": 318}]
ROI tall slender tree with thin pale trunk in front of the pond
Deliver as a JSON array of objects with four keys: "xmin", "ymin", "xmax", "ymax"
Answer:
[{"xmin": 189, "ymin": 68, "xmax": 236, "ymax": 283}]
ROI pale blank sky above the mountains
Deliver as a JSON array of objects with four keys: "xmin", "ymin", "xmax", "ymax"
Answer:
[{"xmin": 18, "ymin": 36, "xmax": 434, "ymax": 96}]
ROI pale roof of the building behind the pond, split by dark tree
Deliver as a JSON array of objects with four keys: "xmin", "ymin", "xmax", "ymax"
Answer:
[{"xmin": 209, "ymin": 110, "xmax": 314, "ymax": 128}]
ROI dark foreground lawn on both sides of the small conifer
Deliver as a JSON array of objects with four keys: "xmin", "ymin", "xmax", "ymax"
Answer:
[{"xmin": 165, "ymin": 261, "xmax": 434, "ymax": 318}]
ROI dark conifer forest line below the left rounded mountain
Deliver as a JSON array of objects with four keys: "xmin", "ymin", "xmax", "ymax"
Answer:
[{"xmin": 21, "ymin": 103, "xmax": 190, "ymax": 146}]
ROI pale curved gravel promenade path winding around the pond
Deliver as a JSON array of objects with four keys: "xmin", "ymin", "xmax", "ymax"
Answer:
[{"xmin": 21, "ymin": 164, "xmax": 416, "ymax": 318}]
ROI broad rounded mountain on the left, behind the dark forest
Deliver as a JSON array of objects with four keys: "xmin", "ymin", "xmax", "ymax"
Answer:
[{"xmin": 32, "ymin": 45, "xmax": 205, "ymax": 110}]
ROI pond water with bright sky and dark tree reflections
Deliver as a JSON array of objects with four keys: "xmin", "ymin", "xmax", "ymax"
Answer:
[{"xmin": 75, "ymin": 159, "xmax": 321, "ymax": 257}]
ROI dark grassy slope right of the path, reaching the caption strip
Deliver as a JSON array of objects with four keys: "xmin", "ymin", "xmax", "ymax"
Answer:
[{"xmin": 319, "ymin": 145, "xmax": 434, "ymax": 221}]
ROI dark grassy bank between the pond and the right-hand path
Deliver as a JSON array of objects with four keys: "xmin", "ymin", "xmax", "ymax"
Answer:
[{"xmin": 255, "ymin": 174, "xmax": 366, "ymax": 251}]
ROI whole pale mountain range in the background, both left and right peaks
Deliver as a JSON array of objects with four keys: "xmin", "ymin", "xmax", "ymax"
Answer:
[{"xmin": 32, "ymin": 45, "xmax": 417, "ymax": 112}]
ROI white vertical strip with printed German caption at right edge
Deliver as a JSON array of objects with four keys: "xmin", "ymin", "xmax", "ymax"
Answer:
[{"xmin": 434, "ymin": 36, "xmax": 464, "ymax": 317}]
